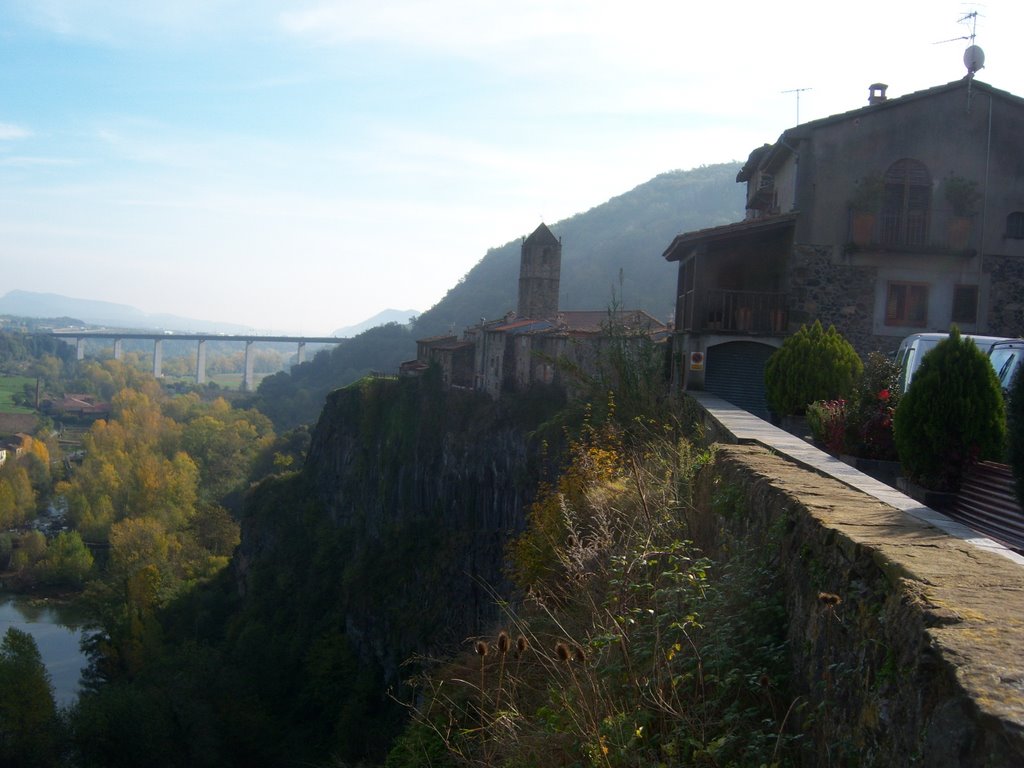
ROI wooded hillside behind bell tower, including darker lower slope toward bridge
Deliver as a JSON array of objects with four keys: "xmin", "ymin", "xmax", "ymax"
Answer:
[{"xmin": 251, "ymin": 163, "xmax": 743, "ymax": 430}]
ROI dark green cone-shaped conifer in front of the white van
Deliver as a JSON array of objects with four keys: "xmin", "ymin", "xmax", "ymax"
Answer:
[{"xmin": 893, "ymin": 326, "xmax": 1007, "ymax": 492}]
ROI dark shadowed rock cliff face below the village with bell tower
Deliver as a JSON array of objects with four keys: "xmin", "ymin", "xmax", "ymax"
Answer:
[{"xmin": 236, "ymin": 380, "xmax": 560, "ymax": 684}]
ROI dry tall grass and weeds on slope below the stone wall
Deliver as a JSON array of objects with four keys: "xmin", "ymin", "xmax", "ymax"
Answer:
[{"xmin": 388, "ymin": 420, "xmax": 799, "ymax": 768}]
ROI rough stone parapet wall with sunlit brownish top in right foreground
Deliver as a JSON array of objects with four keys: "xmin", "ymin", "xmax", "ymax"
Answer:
[{"xmin": 691, "ymin": 445, "xmax": 1024, "ymax": 768}]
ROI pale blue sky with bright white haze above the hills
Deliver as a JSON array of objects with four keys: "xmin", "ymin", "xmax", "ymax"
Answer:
[{"xmin": 0, "ymin": 0, "xmax": 1024, "ymax": 335}]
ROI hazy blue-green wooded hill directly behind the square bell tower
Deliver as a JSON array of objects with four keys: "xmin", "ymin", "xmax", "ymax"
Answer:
[{"xmin": 415, "ymin": 163, "xmax": 743, "ymax": 338}]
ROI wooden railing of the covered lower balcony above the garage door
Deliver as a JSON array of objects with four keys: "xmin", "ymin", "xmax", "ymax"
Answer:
[{"xmin": 680, "ymin": 290, "xmax": 788, "ymax": 334}]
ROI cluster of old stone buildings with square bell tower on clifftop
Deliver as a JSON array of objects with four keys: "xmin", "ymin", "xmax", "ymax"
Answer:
[{"xmin": 399, "ymin": 224, "xmax": 668, "ymax": 398}]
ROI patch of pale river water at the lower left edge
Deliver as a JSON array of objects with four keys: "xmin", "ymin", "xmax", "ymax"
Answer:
[{"xmin": 0, "ymin": 592, "xmax": 87, "ymax": 707}]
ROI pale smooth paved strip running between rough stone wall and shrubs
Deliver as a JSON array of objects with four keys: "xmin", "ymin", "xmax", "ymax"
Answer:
[{"xmin": 687, "ymin": 391, "xmax": 1024, "ymax": 565}]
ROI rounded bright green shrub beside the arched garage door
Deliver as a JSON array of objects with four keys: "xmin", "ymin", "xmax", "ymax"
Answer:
[{"xmin": 765, "ymin": 321, "xmax": 863, "ymax": 416}]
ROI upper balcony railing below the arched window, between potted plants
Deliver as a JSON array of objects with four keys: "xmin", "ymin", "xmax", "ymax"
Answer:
[{"xmin": 848, "ymin": 209, "xmax": 978, "ymax": 253}]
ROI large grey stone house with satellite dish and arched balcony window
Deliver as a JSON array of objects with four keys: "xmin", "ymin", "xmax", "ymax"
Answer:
[{"xmin": 664, "ymin": 74, "xmax": 1024, "ymax": 414}]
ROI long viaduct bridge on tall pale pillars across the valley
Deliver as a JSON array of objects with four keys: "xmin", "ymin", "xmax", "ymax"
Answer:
[{"xmin": 51, "ymin": 330, "xmax": 344, "ymax": 392}]
